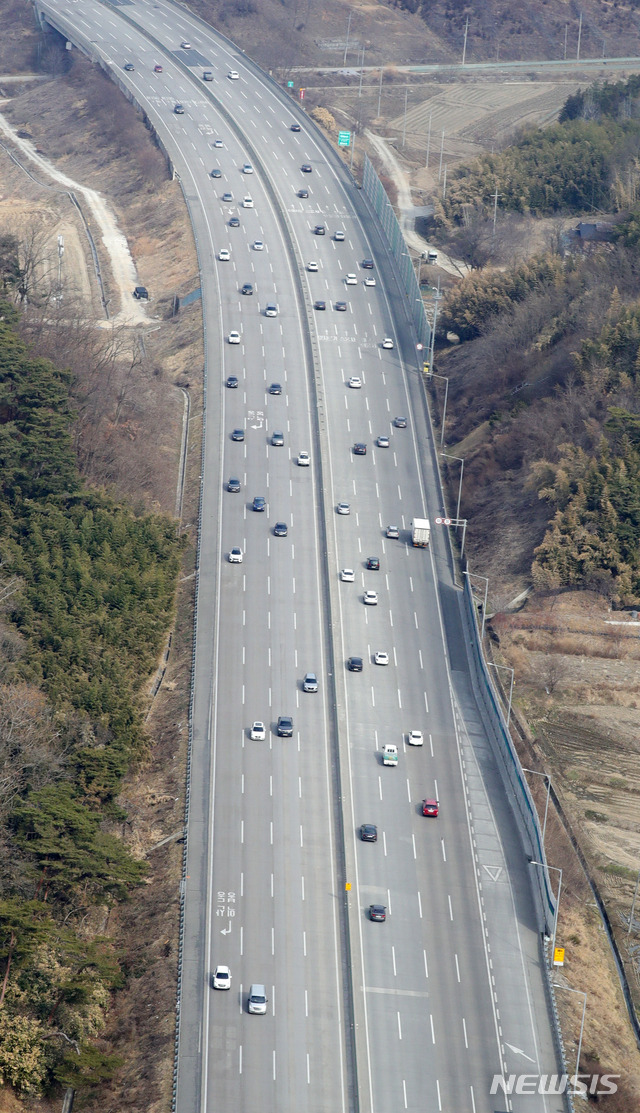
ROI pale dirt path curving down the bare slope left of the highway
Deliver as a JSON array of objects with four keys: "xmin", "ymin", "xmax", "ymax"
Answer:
[{"xmin": 0, "ymin": 114, "xmax": 150, "ymax": 325}]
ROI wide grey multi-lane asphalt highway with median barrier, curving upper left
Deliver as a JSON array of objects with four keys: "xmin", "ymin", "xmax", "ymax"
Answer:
[{"xmin": 35, "ymin": 0, "xmax": 563, "ymax": 1113}]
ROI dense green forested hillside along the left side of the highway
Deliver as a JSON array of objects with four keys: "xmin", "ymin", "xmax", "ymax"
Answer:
[{"xmin": 0, "ymin": 302, "xmax": 181, "ymax": 1094}]
